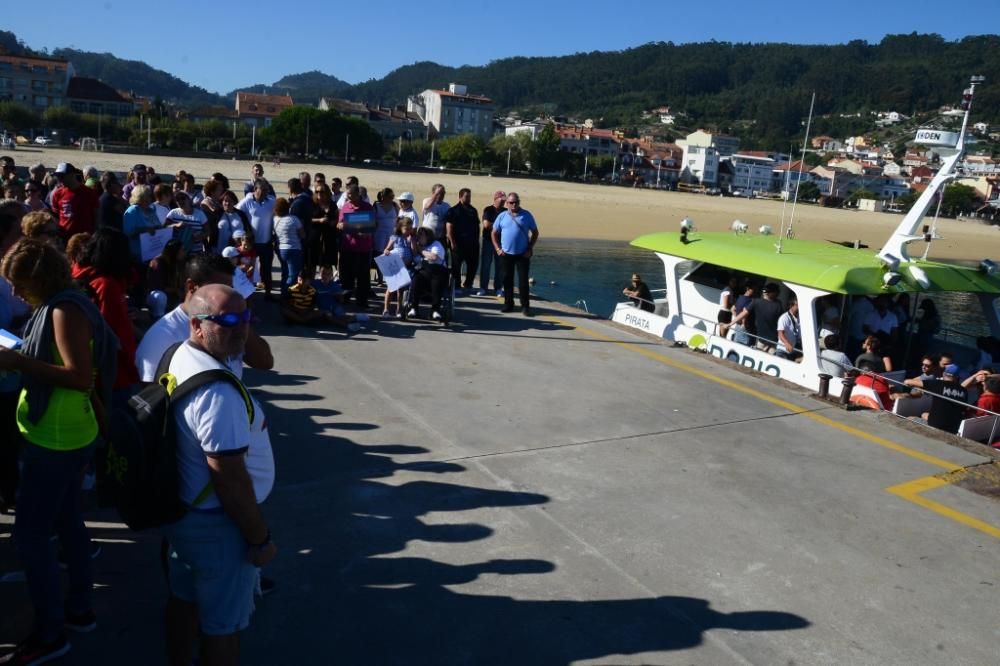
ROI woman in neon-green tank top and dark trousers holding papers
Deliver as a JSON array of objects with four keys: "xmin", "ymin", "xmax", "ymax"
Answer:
[{"xmin": 0, "ymin": 238, "xmax": 118, "ymax": 663}]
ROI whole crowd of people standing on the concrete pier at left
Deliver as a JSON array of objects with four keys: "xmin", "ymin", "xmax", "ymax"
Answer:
[{"xmin": 0, "ymin": 157, "xmax": 538, "ymax": 665}]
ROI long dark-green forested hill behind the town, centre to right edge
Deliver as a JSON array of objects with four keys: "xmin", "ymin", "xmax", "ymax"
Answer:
[{"xmin": 340, "ymin": 34, "xmax": 1000, "ymax": 143}]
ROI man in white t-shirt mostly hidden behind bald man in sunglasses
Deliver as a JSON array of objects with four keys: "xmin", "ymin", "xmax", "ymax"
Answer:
[{"xmin": 135, "ymin": 254, "xmax": 274, "ymax": 382}]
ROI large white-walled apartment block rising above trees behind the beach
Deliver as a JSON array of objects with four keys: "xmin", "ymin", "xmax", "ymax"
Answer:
[{"xmin": 406, "ymin": 83, "xmax": 496, "ymax": 139}]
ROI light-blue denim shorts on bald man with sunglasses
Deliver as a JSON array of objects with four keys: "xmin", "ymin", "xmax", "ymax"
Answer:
[{"xmin": 164, "ymin": 509, "xmax": 258, "ymax": 636}]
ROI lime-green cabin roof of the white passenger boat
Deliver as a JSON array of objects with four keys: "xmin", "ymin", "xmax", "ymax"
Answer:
[{"xmin": 632, "ymin": 232, "xmax": 1000, "ymax": 294}]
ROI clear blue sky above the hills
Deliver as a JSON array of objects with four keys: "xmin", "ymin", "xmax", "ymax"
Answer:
[{"xmin": 0, "ymin": 0, "xmax": 1000, "ymax": 92}]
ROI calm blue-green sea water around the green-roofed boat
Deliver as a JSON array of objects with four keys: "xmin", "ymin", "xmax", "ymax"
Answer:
[{"xmin": 531, "ymin": 238, "xmax": 989, "ymax": 344}]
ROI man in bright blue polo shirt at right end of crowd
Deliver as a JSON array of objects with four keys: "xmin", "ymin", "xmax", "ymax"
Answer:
[{"xmin": 491, "ymin": 192, "xmax": 538, "ymax": 317}]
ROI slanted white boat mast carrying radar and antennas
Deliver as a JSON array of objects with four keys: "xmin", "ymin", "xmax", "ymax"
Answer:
[{"xmin": 878, "ymin": 76, "xmax": 984, "ymax": 265}]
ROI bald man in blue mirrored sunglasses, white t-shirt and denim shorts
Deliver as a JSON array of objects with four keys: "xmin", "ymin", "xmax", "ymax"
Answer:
[{"xmin": 164, "ymin": 284, "xmax": 277, "ymax": 664}]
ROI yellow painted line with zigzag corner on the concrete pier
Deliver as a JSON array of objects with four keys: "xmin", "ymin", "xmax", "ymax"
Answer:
[{"xmin": 545, "ymin": 317, "xmax": 1000, "ymax": 539}]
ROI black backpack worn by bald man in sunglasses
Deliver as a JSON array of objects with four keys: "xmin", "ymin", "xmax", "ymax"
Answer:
[{"xmin": 97, "ymin": 342, "xmax": 254, "ymax": 530}]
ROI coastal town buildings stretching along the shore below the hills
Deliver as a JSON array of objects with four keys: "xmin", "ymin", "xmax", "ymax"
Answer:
[{"xmin": 0, "ymin": 50, "xmax": 1000, "ymax": 220}]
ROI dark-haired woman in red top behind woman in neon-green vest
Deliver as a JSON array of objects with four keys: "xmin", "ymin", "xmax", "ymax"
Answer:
[{"xmin": 73, "ymin": 227, "xmax": 139, "ymax": 405}]
